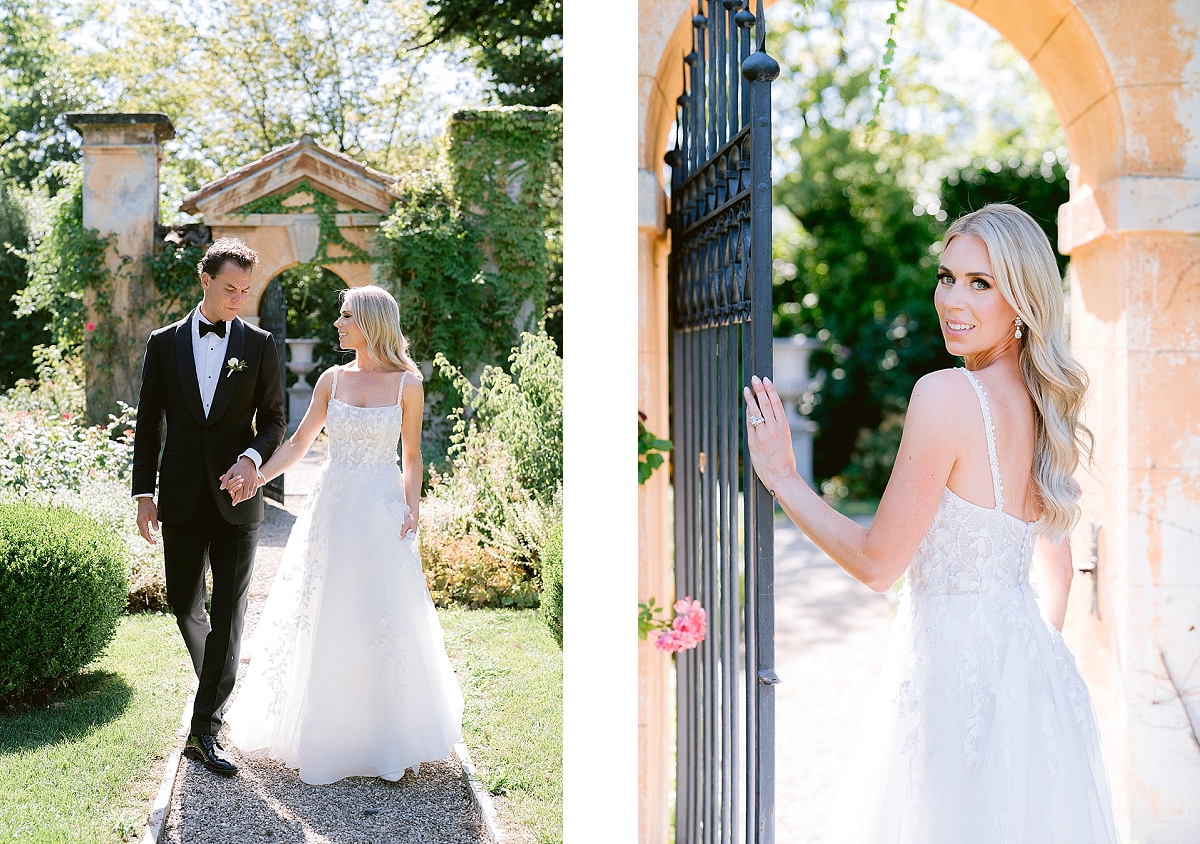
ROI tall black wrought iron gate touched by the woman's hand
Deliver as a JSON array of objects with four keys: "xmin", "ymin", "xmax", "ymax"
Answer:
[{"xmin": 667, "ymin": 0, "xmax": 779, "ymax": 844}]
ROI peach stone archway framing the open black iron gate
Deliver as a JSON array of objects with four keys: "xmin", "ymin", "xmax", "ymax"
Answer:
[{"xmin": 638, "ymin": 0, "xmax": 1200, "ymax": 843}]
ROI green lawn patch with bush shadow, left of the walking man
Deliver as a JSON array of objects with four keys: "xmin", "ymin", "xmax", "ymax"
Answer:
[{"xmin": 0, "ymin": 613, "xmax": 193, "ymax": 844}]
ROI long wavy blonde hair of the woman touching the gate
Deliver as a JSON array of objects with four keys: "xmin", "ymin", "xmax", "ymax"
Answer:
[{"xmin": 942, "ymin": 204, "xmax": 1094, "ymax": 543}]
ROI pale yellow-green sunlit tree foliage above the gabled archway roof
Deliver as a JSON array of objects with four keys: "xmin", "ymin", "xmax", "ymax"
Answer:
[{"xmin": 82, "ymin": 0, "xmax": 463, "ymax": 199}]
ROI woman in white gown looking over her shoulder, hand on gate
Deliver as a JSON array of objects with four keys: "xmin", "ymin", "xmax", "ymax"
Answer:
[{"xmin": 745, "ymin": 204, "xmax": 1116, "ymax": 844}]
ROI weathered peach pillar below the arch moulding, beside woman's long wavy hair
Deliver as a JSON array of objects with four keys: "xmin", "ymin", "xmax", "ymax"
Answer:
[{"xmin": 1061, "ymin": 219, "xmax": 1200, "ymax": 843}]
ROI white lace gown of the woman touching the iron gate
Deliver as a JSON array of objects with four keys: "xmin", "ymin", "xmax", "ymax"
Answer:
[{"xmin": 824, "ymin": 370, "xmax": 1117, "ymax": 844}]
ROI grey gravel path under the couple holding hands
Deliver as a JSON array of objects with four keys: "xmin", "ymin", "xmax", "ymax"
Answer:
[{"xmin": 161, "ymin": 438, "xmax": 486, "ymax": 844}]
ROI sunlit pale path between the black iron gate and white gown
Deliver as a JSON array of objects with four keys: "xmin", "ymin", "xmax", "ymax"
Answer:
[{"xmin": 775, "ymin": 519, "xmax": 895, "ymax": 844}]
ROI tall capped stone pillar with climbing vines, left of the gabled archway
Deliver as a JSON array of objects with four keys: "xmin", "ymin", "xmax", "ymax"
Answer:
[{"xmin": 66, "ymin": 112, "xmax": 175, "ymax": 421}]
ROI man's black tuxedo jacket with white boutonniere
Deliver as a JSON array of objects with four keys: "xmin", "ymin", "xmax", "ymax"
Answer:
[{"xmin": 133, "ymin": 310, "xmax": 287, "ymax": 525}]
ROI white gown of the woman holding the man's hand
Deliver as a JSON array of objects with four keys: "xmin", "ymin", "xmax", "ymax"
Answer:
[{"xmin": 227, "ymin": 371, "xmax": 463, "ymax": 785}]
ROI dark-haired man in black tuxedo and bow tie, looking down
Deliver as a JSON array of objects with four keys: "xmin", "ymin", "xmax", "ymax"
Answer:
[{"xmin": 133, "ymin": 238, "xmax": 286, "ymax": 774}]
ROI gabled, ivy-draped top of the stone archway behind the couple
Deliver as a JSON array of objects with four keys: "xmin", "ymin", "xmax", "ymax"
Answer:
[{"xmin": 180, "ymin": 134, "xmax": 397, "ymax": 313}]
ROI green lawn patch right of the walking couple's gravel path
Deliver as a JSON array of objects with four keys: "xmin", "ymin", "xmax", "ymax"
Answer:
[{"xmin": 438, "ymin": 607, "xmax": 563, "ymax": 844}]
